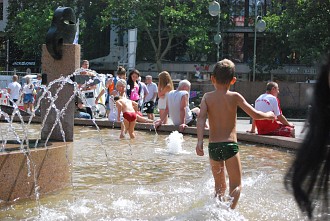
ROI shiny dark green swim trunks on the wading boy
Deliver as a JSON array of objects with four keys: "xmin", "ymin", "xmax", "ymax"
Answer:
[{"xmin": 209, "ymin": 142, "xmax": 239, "ymax": 161}]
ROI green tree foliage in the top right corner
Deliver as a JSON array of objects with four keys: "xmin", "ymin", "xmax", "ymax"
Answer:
[{"xmin": 282, "ymin": 0, "xmax": 330, "ymax": 64}]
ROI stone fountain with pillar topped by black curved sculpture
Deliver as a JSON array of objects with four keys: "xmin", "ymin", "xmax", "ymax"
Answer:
[{"xmin": 0, "ymin": 7, "xmax": 80, "ymax": 204}]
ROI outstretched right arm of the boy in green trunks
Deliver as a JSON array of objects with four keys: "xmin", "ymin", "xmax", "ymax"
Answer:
[{"xmin": 237, "ymin": 93, "xmax": 276, "ymax": 120}]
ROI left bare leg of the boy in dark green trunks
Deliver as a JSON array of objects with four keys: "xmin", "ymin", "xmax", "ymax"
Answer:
[{"xmin": 210, "ymin": 159, "xmax": 226, "ymax": 197}]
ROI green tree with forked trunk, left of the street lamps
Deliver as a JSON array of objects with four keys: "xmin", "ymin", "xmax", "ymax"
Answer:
[{"xmin": 102, "ymin": 0, "xmax": 214, "ymax": 71}]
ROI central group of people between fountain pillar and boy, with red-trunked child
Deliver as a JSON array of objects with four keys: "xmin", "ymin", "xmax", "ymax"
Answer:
[{"xmin": 75, "ymin": 60, "xmax": 207, "ymax": 138}]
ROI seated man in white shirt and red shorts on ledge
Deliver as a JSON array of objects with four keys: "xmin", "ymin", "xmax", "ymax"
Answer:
[{"xmin": 247, "ymin": 82, "xmax": 295, "ymax": 137}]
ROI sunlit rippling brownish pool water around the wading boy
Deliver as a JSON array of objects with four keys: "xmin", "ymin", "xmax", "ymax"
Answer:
[{"xmin": 0, "ymin": 125, "xmax": 307, "ymax": 221}]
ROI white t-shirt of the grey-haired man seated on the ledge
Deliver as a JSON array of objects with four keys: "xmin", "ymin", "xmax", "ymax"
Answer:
[{"xmin": 167, "ymin": 90, "xmax": 193, "ymax": 126}]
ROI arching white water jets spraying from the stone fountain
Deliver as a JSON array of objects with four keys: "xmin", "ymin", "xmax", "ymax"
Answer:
[{"xmin": 0, "ymin": 69, "xmax": 109, "ymax": 214}]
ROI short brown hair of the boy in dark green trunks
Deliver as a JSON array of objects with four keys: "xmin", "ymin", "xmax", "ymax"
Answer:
[{"xmin": 212, "ymin": 59, "xmax": 235, "ymax": 84}]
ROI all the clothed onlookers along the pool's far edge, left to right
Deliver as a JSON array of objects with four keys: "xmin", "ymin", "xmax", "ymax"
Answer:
[{"xmin": 3, "ymin": 60, "xmax": 302, "ymax": 142}]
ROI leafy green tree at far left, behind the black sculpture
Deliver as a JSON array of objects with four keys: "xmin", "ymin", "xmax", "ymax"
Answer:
[{"xmin": 6, "ymin": 0, "xmax": 79, "ymax": 60}]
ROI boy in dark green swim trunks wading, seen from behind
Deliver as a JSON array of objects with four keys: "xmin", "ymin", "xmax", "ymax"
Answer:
[{"xmin": 196, "ymin": 59, "xmax": 275, "ymax": 209}]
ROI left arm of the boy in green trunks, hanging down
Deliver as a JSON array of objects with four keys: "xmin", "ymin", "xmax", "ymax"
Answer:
[{"xmin": 196, "ymin": 95, "xmax": 207, "ymax": 156}]
